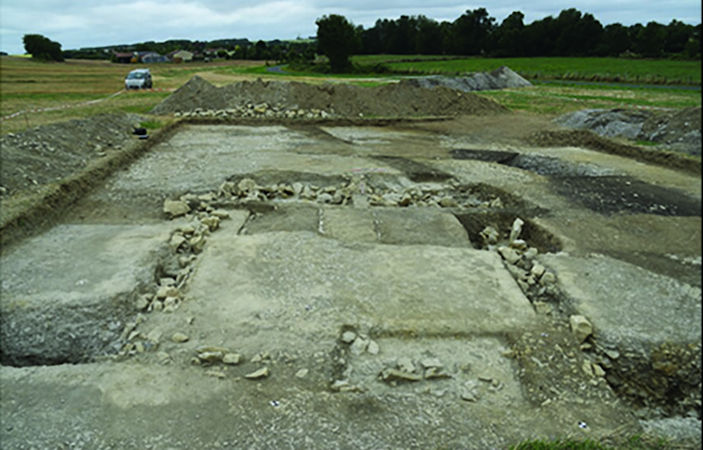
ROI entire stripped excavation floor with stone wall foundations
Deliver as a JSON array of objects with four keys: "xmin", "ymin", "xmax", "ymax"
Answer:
[{"xmin": 0, "ymin": 117, "xmax": 701, "ymax": 449}]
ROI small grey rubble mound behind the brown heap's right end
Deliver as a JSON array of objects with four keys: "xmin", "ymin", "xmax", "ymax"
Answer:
[{"xmin": 409, "ymin": 66, "xmax": 532, "ymax": 92}]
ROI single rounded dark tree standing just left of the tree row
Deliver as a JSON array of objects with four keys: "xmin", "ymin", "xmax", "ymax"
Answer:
[{"xmin": 315, "ymin": 14, "xmax": 361, "ymax": 72}]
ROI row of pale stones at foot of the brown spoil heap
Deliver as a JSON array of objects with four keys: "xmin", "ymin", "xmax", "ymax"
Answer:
[{"xmin": 174, "ymin": 103, "xmax": 333, "ymax": 120}]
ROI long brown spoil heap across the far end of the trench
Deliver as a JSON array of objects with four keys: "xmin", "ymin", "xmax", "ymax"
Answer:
[{"xmin": 152, "ymin": 76, "xmax": 507, "ymax": 117}]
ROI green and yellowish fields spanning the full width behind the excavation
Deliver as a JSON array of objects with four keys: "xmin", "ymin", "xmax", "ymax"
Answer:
[{"xmin": 0, "ymin": 55, "xmax": 701, "ymax": 133}]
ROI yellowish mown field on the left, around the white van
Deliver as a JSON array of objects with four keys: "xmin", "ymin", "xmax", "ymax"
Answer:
[{"xmin": 0, "ymin": 56, "xmax": 263, "ymax": 133}]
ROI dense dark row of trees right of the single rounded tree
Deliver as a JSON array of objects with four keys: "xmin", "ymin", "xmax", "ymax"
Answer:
[{"xmin": 356, "ymin": 8, "xmax": 701, "ymax": 59}]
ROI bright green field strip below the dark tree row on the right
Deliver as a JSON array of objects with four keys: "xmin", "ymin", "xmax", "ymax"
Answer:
[{"xmin": 376, "ymin": 58, "xmax": 701, "ymax": 85}]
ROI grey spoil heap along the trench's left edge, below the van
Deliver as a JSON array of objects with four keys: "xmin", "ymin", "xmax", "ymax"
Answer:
[{"xmin": 0, "ymin": 114, "xmax": 141, "ymax": 197}]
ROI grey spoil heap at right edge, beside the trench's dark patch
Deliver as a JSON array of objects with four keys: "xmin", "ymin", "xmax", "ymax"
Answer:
[{"xmin": 555, "ymin": 107, "xmax": 701, "ymax": 155}]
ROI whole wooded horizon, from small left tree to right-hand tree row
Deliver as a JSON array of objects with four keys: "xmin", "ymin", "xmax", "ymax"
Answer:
[{"xmin": 25, "ymin": 8, "xmax": 701, "ymax": 64}]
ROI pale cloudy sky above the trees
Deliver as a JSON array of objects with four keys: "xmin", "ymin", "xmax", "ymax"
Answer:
[{"xmin": 0, "ymin": 0, "xmax": 701, "ymax": 54}]
